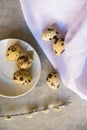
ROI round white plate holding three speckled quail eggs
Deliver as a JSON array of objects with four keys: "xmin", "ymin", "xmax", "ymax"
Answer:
[{"xmin": 0, "ymin": 39, "xmax": 41, "ymax": 98}]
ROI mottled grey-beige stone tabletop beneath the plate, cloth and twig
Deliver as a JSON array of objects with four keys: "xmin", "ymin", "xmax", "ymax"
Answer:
[{"xmin": 0, "ymin": 0, "xmax": 87, "ymax": 130}]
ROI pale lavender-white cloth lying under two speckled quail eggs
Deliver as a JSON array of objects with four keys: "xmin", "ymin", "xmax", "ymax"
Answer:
[{"xmin": 20, "ymin": 0, "xmax": 87, "ymax": 100}]
